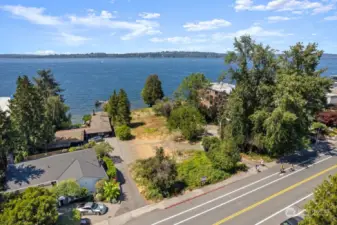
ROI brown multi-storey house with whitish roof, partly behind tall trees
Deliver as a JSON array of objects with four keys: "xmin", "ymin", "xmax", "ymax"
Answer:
[{"xmin": 201, "ymin": 82, "xmax": 235, "ymax": 108}]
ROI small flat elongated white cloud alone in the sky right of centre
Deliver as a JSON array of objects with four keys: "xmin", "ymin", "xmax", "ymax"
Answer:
[{"xmin": 183, "ymin": 19, "xmax": 232, "ymax": 31}]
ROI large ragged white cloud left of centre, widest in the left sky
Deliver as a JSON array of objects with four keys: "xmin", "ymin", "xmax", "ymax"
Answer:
[{"xmin": 69, "ymin": 11, "xmax": 161, "ymax": 40}]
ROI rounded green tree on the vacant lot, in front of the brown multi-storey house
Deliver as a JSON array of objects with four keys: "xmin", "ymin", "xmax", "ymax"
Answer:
[{"xmin": 167, "ymin": 105, "xmax": 205, "ymax": 141}]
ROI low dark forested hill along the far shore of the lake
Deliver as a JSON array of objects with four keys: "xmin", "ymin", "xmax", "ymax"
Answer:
[{"xmin": 0, "ymin": 51, "xmax": 225, "ymax": 58}]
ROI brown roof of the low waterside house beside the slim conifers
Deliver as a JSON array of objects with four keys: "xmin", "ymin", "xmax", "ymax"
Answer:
[{"xmin": 85, "ymin": 112, "xmax": 112, "ymax": 134}]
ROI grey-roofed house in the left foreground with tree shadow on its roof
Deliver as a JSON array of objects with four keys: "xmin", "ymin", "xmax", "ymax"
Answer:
[{"xmin": 6, "ymin": 149, "xmax": 107, "ymax": 192}]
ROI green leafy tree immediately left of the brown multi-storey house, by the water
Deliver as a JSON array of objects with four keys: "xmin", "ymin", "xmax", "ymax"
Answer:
[{"xmin": 174, "ymin": 73, "xmax": 210, "ymax": 107}]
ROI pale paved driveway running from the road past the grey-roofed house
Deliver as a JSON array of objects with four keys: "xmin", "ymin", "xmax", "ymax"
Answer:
[{"xmin": 105, "ymin": 137, "xmax": 146, "ymax": 216}]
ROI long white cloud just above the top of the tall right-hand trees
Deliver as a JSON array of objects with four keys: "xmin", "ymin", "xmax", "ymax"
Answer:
[{"xmin": 212, "ymin": 25, "xmax": 292, "ymax": 41}]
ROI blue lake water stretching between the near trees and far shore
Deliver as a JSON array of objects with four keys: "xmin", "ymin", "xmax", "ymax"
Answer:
[{"xmin": 0, "ymin": 57, "xmax": 337, "ymax": 122}]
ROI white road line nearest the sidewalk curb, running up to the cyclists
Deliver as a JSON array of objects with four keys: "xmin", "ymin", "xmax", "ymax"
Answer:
[{"xmin": 151, "ymin": 154, "xmax": 332, "ymax": 225}]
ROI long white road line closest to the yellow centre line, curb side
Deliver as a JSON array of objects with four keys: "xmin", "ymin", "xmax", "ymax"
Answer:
[{"xmin": 174, "ymin": 156, "xmax": 332, "ymax": 225}]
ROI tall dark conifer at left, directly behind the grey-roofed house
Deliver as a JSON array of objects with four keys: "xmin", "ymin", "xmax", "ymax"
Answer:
[{"xmin": 9, "ymin": 76, "xmax": 54, "ymax": 153}]
